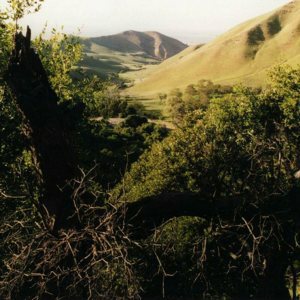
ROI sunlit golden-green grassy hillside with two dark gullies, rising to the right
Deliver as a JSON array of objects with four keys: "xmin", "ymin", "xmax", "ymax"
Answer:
[{"xmin": 127, "ymin": 0, "xmax": 300, "ymax": 98}]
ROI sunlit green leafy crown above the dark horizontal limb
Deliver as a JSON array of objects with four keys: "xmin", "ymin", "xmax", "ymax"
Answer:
[{"xmin": 122, "ymin": 75, "xmax": 299, "ymax": 199}]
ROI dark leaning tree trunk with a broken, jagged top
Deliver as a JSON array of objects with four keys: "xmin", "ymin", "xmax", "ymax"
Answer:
[{"xmin": 6, "ymin": 28, "xmax": 77, "ymax": 231}]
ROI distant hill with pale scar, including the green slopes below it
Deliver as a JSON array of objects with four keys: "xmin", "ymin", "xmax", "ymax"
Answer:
[{"xmin": 80, "ymin": 30, "xmax": 187, "ymax": 75}]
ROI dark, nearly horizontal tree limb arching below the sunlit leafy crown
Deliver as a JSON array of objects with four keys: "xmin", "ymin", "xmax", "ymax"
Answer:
[{"xmin": 126, "ymin": 187, "xmax": 300, "ymax": 238}]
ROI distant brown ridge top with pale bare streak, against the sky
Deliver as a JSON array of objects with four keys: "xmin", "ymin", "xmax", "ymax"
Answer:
[{"xmin": 84, "ymin": 30, "xmax": 187, "ymax": 60}]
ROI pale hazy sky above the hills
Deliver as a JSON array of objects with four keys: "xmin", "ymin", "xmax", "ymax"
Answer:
[{"xmin": 0, "ymin": 0, "xmax": 292, "ymax": 43}]
